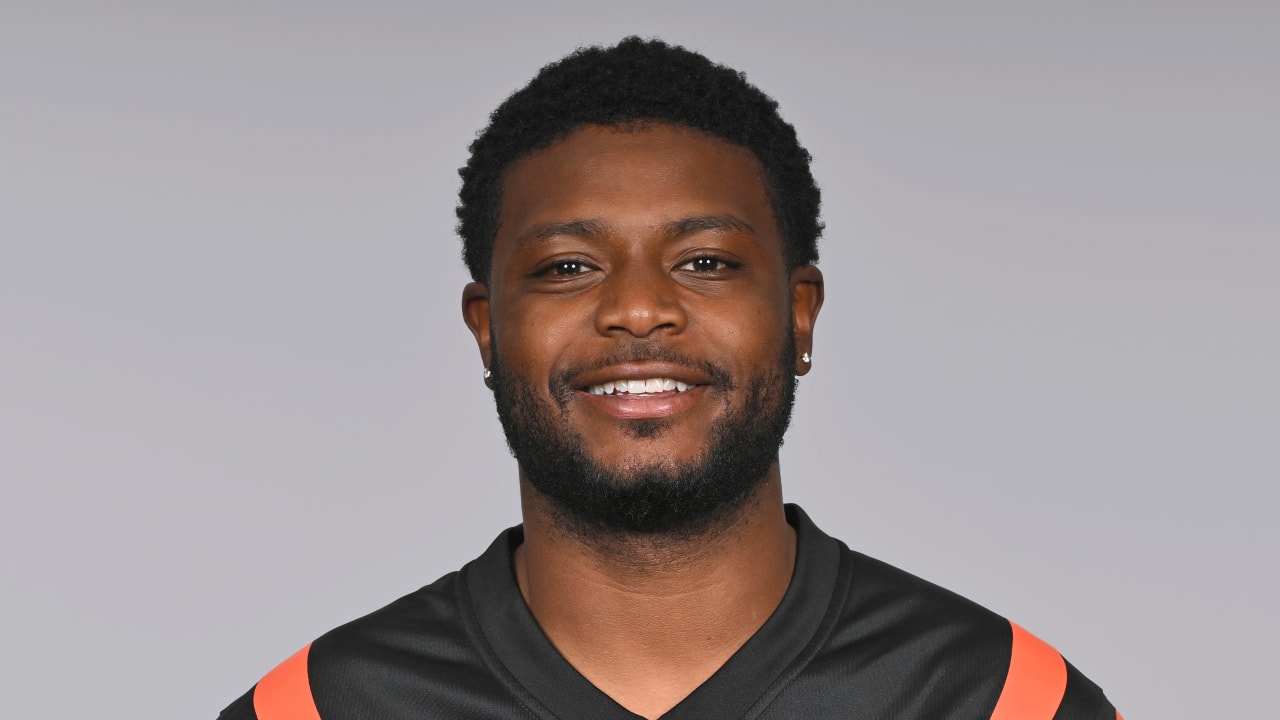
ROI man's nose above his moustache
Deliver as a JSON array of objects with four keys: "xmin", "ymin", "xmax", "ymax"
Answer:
[{"xmin": 595, "ymin": 261, "xmax": 689, "ymax": 337}]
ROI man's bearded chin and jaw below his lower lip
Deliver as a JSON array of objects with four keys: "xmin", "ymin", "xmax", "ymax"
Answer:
[{"xmin": 490, "ymin": 333, "xmax": 795, "ymax": 537}]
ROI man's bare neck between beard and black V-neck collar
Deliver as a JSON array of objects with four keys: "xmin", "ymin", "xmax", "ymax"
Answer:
[{"xmin": 516, "ymin": 464, "xmax": 795, "ymax": 717}]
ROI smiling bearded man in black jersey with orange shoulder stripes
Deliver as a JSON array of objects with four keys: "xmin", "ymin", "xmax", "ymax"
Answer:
[{"xmin": 223, "ymin": 38, "xmax": 1117, "ymax": 720}]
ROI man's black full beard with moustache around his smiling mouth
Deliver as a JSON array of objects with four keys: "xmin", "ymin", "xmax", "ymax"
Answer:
[{"xmin": 490, "ymin": 329, "xmax": 796, "ymax": 539}]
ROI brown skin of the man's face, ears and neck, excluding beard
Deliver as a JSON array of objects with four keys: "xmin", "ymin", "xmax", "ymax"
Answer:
[{"xmin": 462, "ymin": 123, "xmax": 823, "ymax": 717}]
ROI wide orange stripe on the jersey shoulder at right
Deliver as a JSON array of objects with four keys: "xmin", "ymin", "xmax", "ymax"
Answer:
[{"xmin": 991, "ymin": 623, "xmax": 1066, "ymax": 720}]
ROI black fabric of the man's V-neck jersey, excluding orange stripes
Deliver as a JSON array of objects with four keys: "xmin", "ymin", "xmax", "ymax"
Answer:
[{"xmin": 219, "ymin": 505, "xmax": 1117, "ymax": 720}]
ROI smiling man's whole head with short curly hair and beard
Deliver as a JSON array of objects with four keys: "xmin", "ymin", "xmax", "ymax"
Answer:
[{"xmin": 460, "ymin": 41, "xmax": 822, "ymax": 536}]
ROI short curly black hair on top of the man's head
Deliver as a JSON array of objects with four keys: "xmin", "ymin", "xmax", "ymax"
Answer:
[{"xmin": 458, "ymin": 37, "xmax": 822, "ymax": 282}]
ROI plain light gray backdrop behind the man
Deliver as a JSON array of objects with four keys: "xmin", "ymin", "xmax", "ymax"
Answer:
[{"xmin": 0, "ymin": 0, "xmax": 1280, "ymax": 720}]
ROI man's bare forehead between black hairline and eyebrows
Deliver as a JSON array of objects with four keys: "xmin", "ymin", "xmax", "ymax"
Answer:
[{"xmin": 494, "ymin": 123, "xmax": 781, "ymax": 252}]
